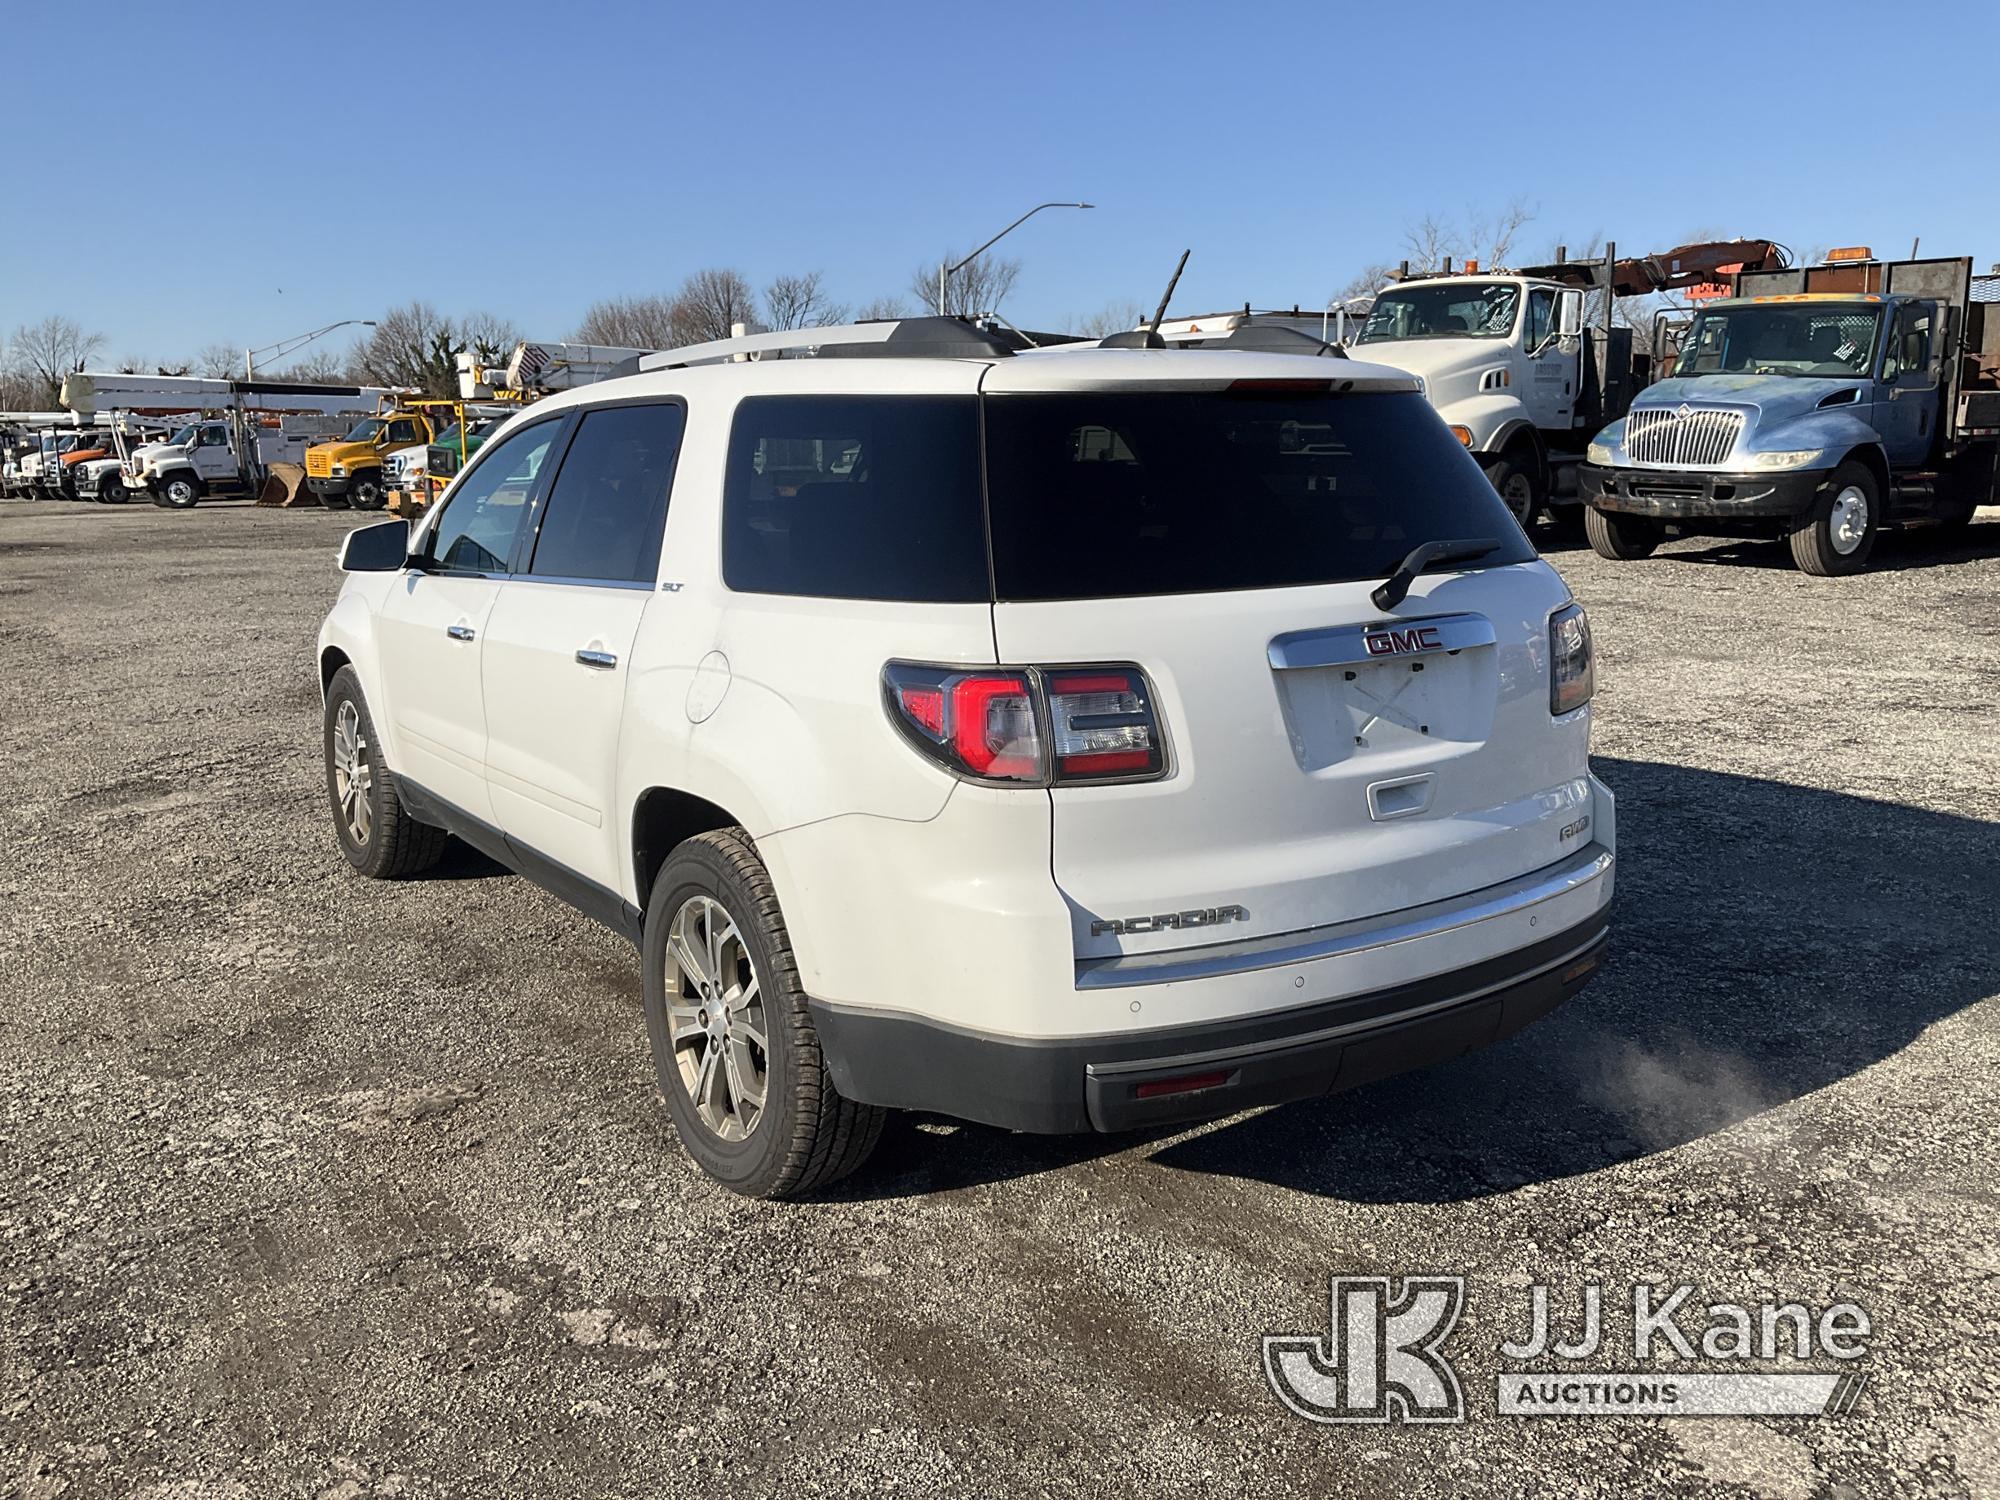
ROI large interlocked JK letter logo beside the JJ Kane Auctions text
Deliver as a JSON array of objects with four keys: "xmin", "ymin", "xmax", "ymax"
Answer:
[{"xmin": 1264, "ymin": 1276, "xmax": 1466, "ymax": 1422}]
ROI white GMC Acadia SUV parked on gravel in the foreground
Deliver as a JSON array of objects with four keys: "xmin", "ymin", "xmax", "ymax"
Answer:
[{"xmin": 320, "ymin": 318, "xmax": 1614, "ymax": 1196}]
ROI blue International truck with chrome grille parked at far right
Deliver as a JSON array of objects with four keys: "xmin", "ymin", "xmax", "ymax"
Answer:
[{"xmin": 1578, "ymin": 248, "xmax": 2000, "ymax": 578}]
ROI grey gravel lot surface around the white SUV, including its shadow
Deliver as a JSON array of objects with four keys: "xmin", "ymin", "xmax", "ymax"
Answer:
[{"xmin": 0, "ymin": 504, "xmax": 2000, "ymax": 1500}]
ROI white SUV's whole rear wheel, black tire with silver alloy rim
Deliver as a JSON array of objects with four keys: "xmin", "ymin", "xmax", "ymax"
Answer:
[{"xmin": 642, "ymin": 828, "xmax": 886, "ymax": 1198}]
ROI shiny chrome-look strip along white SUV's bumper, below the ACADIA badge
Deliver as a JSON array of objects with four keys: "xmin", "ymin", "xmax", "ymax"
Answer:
[{"xmin": 1076, "ymin": 842, "xmax": 1614, "ymax": 990}]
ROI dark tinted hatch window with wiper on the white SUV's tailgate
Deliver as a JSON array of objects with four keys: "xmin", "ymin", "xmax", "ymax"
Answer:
[{"xmin": 986, "ymin": 392, "xmax": 1534, "ymax": 600}]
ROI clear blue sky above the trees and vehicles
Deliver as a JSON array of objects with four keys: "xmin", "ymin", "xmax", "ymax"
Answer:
[{"xmin": 0, "ymin": 0, "xmax": 2000, "ymax": 360}]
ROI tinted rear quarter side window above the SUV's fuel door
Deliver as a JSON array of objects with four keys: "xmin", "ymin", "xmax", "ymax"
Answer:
[{"xmin": 722, "ymin": 406, "xmax": 990, "ymax": 604}]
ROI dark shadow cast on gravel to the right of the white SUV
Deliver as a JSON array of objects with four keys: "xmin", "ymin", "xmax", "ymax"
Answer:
[{"xmin": 1128, "ymin": 758, "xmax": 2000, "ymax": 1202}]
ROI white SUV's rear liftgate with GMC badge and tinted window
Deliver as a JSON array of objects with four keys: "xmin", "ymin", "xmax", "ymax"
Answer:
[{"xmin": 986, "ymin": 352, "xmax": 1588, "ymax": 958}]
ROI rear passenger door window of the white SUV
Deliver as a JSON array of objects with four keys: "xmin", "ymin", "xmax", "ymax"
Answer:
[{"xmin": 528, "ymin": 404, "xmax": 686, "ymax": 584}]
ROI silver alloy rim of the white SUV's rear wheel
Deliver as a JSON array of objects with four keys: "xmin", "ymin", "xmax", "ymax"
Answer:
[{"xmin": 666, "ymin": 896, "xmax": 770, "ymax": 1140}]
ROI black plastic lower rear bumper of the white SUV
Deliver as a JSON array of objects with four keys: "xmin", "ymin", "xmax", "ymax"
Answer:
[{"xmin": 810, "ymin": 868, "xmax": 1610, "ymax": 1134}]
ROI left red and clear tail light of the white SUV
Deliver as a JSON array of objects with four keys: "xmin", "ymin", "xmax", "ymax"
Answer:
[{"xmin": 882, "ymin": 662, "xmax": 1166, "ymax": 786}]
